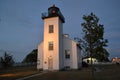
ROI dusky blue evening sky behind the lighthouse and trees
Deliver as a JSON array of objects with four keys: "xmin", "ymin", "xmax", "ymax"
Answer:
[{"xmin": 0, "ymin": 0, "xmax": 120, "ymax": 62}]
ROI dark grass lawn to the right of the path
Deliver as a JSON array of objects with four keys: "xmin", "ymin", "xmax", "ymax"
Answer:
[{"xmin": 26, "ymin": 65, "xmax": 120, "ymax": 80}]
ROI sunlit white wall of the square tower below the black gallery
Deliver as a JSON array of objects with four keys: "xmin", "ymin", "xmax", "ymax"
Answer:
[{"xmin": 43, "ymin": 17, "xmax": 63, "ymax": 70}]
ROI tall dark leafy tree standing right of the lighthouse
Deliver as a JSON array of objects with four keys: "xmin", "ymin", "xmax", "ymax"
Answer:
[{"xmin": 81, "ymin": 13, "xmax": 109, "ymax": 61}]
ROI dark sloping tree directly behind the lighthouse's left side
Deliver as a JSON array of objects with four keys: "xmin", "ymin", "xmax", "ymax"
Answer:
[{"xmin": 22, "ymin": 49, "xmax": 37, "ymax": 62}]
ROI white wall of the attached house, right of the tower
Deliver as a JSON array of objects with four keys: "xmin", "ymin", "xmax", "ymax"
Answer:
[{"xmin": 63, "ymin": 36, "xmax": 81, "ymax": 69}]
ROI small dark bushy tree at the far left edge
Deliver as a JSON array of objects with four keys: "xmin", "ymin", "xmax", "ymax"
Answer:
[{"xmin": 0, "ymin": 52, "xmax": 14, "ymax": 68}]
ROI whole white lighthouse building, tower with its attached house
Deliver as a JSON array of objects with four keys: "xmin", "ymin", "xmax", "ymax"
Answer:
[{"xmin": 37, "ymin": 5, "xmax": 80, "ymax": 70}]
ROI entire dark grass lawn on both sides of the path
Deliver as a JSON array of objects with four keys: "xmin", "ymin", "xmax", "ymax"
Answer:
[{"xmin": 0, "ymin": 65, "xmax": 120, "ymax": 80}]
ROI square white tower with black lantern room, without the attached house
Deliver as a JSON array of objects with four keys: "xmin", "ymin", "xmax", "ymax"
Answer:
[{"xmin": 40, "ymin": 5, "xmax": 65, "ymax": 70}]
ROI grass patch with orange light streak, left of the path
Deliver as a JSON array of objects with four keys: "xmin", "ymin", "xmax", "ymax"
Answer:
[{"xmin": 0, "ymin": 66, "xmax": 40, "ymax": 80}]
